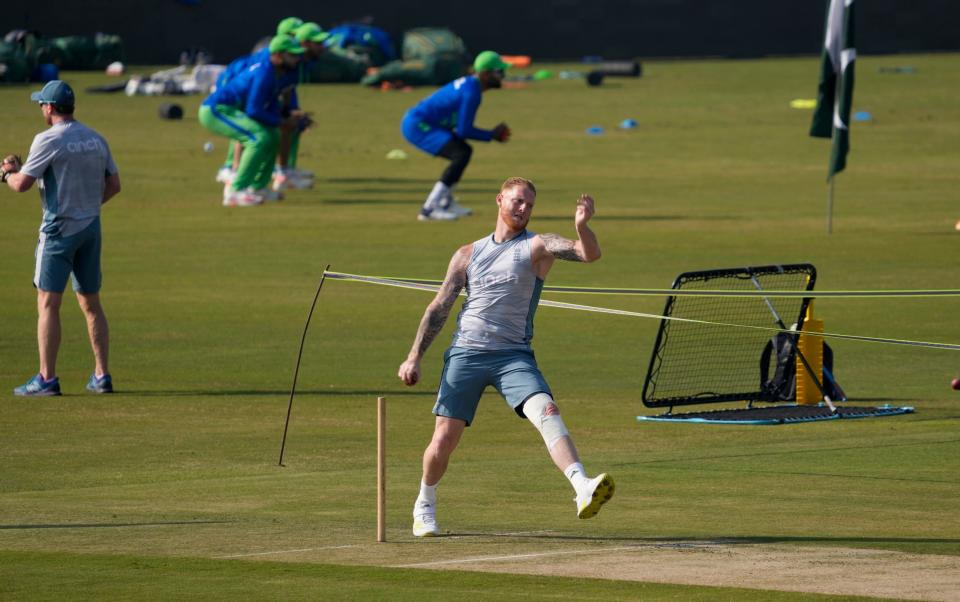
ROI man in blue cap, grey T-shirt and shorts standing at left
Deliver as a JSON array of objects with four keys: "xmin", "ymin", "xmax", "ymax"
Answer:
[{"xmin": 0, "ymin": 80, "xmax": 120, "ymax": 396}]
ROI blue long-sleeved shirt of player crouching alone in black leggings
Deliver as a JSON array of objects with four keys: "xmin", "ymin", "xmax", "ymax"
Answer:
[{"xmin": 410, "ymin": 75, "xmax": 493, "ymax": 142}]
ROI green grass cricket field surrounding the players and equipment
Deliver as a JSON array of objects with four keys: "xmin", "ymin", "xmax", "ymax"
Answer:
[{"xmin": 0, "ymin": 54, "xmax": 960, "ymax": 600}]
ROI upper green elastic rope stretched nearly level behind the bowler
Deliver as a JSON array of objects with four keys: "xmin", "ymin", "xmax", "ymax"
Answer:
[{"xmin": 326, "ymin": 272, "xmax": 960, "ymax": 299}]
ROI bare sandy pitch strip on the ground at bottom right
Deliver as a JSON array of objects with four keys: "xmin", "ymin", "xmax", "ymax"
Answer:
[{"xmin": 404, "ymin": 542, "xmax": 960, "ymax": 601}]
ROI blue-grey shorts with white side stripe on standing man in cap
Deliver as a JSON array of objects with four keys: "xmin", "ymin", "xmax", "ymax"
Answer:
[{"xmin": 33, "ymin": 217, "xmax": 102, "ymax": 295}]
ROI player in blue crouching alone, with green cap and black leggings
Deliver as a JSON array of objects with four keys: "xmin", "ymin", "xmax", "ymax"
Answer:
[{"xmin": 401, "ymin": 50, "xmax": 510, "ymax": 221}]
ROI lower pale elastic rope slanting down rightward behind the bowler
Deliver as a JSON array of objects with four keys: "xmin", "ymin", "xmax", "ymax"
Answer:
[{"xmin": 324, "ymin": 272, "xmax": 960, "ymax": 351}]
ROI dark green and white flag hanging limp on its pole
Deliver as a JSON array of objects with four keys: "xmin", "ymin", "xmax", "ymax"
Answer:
[{"xmin": 810, "ymin": 0, "xmax": 857, "ymax": 180}]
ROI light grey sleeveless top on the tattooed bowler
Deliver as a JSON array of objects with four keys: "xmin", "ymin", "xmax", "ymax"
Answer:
[{"xmin": 453, "ymin": 230, "xmax": 543, "ymax": 351}]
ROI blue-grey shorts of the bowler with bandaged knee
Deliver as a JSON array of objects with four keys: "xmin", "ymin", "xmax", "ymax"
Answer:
[{"xmin": 433, "ymin": 347, "xmax": 552, "ymax": 426}]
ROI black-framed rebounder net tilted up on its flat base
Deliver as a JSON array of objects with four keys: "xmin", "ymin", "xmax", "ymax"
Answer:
[{"xmin": 637, "ymin": 263, "xmax": 913, "ymax": 424}]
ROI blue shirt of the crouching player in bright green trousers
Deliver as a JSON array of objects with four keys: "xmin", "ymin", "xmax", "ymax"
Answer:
[{"xmin": 203, "ymin": 60, "xmax": 280, "ymax": 127}]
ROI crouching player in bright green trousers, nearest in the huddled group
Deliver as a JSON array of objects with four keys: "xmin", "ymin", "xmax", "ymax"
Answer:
[{"xmin": 199, "ymin": 35, "xmax": 303, "ymax": 206}]
